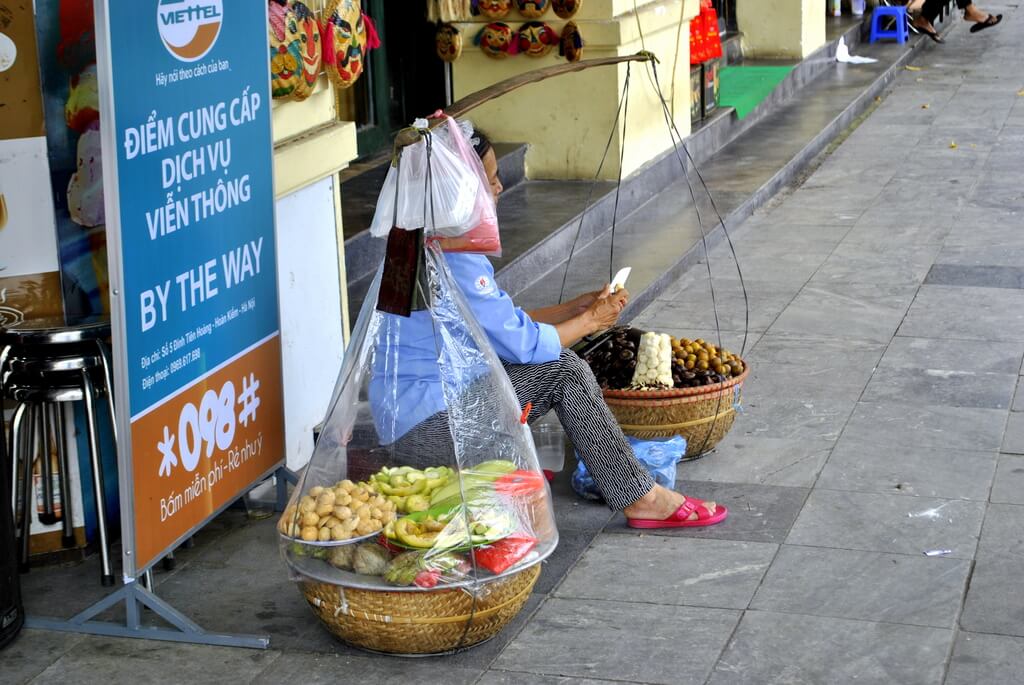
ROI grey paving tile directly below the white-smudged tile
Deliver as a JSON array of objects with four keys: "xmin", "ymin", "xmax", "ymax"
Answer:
[{"xmin": 751, "ymin": 545, "xmax": 971, "ymax": 628}]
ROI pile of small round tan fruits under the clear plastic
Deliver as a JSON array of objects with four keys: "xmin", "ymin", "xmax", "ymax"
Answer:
[{"xmin": 278, "ymin": 480, "xmax": 396, "ymax": 543}]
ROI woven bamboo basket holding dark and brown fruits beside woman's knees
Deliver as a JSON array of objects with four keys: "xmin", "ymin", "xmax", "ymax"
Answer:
[{"xmin": 604, "ymin": 362, "xmax": 750, "ymax": 460}]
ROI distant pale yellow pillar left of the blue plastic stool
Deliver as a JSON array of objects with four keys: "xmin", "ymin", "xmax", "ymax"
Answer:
[{"xmin": 736, "ymin": 0, "xmax": 825, "ymax": 59}]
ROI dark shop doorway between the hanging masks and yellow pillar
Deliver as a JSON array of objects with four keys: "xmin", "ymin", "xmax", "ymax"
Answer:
[{"xmin": 338, "ymin": 0, "xmax": 447, "ymax": 159}]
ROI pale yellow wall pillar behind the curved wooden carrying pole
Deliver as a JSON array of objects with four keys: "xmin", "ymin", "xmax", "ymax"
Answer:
[{"xmin": 453, "ymin": 0, "xmax": 699, "ymax": 178}]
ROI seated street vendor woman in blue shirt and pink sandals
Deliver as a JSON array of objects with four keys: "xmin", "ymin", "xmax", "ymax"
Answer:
[{"xmin": 372, "ymin": 122, "xmax": 728, "ymax": 528}]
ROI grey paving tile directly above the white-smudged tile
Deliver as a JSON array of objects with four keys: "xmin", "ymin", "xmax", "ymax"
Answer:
[{"xmin": 817, "ymin": 436, "xmax": 996, "ymax": 502}]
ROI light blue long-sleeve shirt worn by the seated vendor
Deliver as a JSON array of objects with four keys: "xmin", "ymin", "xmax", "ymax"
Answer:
[{"xmin": 370, "ymin": 253, "xmax": 562, "ymax": 444}]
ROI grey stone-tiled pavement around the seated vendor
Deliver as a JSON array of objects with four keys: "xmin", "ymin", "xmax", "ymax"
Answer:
[{"xmin": 6, "ymin": 5, "xmax": 1024, "ymax": 685}]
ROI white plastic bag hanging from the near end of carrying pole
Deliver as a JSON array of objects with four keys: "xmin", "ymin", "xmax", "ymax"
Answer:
[{"xmin": 370, "ymin": 122, "xmax": 486, "ymax": 238}]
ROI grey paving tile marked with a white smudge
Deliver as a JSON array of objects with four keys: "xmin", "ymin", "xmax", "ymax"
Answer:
[{"xmin": 785, "ymin": 489, "xmax": 985, "ymax": 559}]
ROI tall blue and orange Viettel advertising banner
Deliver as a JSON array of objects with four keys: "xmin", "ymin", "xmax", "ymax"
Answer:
[{"xmin": 96, "ymin": 0, "xmax": 284, "ymax": 573}]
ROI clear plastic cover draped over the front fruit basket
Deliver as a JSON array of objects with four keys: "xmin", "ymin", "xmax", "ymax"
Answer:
[{"xmin": 278, "ymin": 240, "xmax": 558, "ymax": 593}]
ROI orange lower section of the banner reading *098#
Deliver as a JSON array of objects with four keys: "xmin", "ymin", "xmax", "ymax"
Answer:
[{"xmin": 131, "ymin": 335, "xmax": 285, "ymax": 569}]
